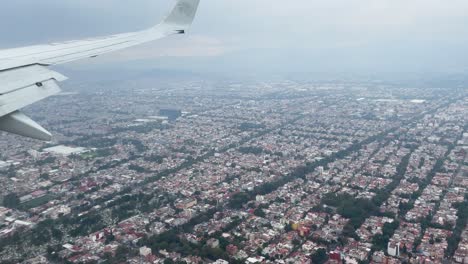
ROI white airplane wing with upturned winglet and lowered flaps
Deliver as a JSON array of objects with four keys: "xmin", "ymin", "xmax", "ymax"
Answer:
[{"xmin": 0, "ymin": 0, "xmax": 200, "ymax": 141}]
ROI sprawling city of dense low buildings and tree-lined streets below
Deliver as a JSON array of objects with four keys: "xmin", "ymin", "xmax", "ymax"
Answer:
[{"xmin": 0, "ymin": 74, "xmax": 468, "ymax": 264}]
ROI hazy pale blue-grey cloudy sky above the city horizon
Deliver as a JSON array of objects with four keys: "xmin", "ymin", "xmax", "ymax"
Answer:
[{"xmin": 0, "ymin": 0, "xmax": 468, "ymax": 76}]
